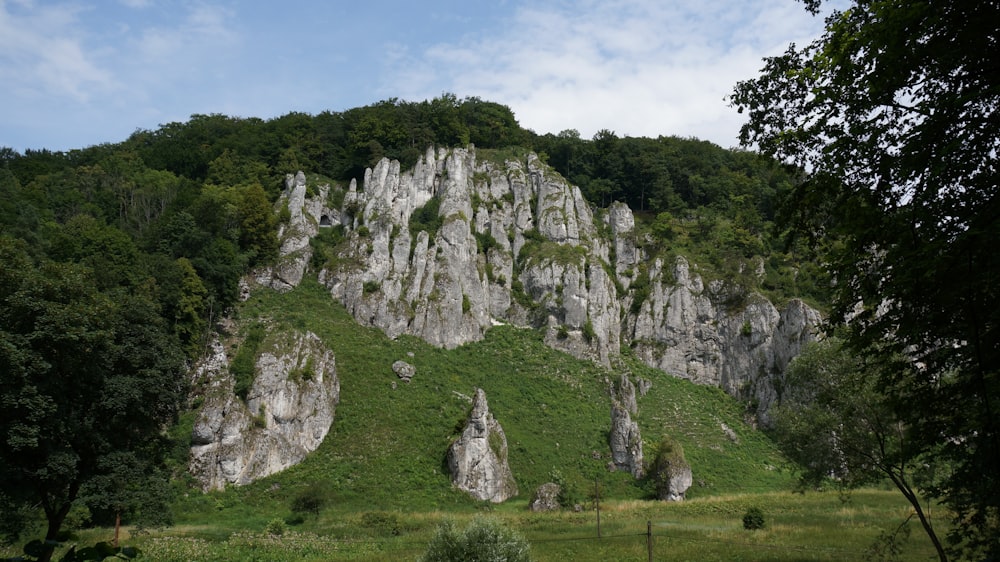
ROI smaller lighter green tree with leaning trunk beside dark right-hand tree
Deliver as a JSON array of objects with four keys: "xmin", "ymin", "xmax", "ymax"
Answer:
[{"xmin": 772, "ymin": 337, "xmax": 947, "ymax": 560}]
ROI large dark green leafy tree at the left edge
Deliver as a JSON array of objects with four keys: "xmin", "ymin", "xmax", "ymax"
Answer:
[{"xmin": 0, "ymin": 237, "xmax": 184, "ymax": 561}]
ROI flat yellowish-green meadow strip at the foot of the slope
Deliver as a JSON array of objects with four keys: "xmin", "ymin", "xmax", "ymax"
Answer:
[{"xmin": 0, "ymin": 490, "xmax": 943, "ymax": 562}]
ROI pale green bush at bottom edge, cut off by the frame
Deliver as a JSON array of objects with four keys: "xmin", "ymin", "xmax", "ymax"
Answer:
[{"xmin": 420, "ymin": 517, "xmax": 531, "ymax": 562}]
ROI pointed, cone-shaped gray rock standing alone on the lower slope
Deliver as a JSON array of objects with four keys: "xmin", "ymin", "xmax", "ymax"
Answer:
[{"xmin": 448, "ymin": 388, "xmax": 517, "ymax": 503}]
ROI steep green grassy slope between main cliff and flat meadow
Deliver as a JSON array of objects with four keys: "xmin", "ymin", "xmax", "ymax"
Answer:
[{"xmin": 178, "ymin": 280, "xmax": 791, "ymax": 524}]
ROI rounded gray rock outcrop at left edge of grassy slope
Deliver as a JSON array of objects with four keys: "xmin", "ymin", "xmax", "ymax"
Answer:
[{"xmin": 189, "ymin": 333, "xmax": 340, "ymax": 491}]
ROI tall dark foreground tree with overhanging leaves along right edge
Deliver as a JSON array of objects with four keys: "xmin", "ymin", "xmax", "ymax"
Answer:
[{"xmin": 732, "ymin": 0, "xmax": 1000, "ymax": 558}]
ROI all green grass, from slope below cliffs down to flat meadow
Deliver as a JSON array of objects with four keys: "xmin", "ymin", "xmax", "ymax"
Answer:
[{"xmin": 0, "ymin": 281, "xmax": 943, "ymax": 562}]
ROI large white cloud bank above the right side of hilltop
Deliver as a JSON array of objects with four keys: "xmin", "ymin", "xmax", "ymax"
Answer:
[{"xmin": 400, "ymin": 0, "xmax": 822, "ymax": 146}]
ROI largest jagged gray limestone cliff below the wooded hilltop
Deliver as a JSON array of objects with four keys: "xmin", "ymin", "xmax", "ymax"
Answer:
[{"xmin": 278, "ymin": 147, "xmax": 819, "ymax": 421}]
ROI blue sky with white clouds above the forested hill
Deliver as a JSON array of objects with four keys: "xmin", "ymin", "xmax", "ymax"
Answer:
[{"xmin": 0, "ymin": 0, "xmax": 823, "ymax": 151}]
